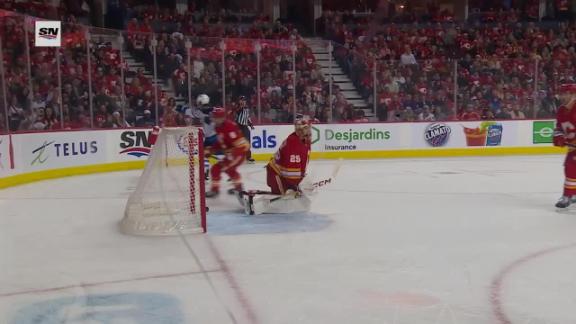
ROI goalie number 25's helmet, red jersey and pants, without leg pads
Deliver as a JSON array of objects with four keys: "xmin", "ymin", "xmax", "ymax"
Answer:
[{"xmin": 266, "ymin": 115, "xmax": 312, "ymax": 195}]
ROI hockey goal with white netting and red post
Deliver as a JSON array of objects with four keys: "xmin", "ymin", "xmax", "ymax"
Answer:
[{"xmin": 120, "ymin": 127, "xmax": 206, "ymax": 235}]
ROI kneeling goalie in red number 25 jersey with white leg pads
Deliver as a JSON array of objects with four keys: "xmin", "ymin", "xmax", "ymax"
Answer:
[{"xmin": 243, "ymin": 115, "xmax": 313, "ymax": 215}]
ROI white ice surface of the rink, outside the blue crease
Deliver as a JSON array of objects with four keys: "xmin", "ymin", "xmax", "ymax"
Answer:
[{"xmin": 0, "ymin": 156, "xmax": 576, "ymax": 324}]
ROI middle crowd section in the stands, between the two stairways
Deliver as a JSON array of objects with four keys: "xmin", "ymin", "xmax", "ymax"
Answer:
[{"xmin": 122, "ymin": 7, "xmax": 342, "ymax": 122}]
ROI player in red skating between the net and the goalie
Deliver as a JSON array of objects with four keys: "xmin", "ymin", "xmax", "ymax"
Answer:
[{"xmin": 206, "ymin": 107, "xmax": 250, "ymax": 198}]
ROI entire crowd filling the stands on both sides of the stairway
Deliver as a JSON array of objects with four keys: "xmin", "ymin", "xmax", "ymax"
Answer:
[{"xmin": 0, "ymin": 0, "xmax": 576, "ymax": 131}]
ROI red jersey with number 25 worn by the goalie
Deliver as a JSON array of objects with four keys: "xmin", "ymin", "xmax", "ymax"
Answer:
[{"xmin": 268, "ymin": 132, "xmax": 310, "ymax": 186}]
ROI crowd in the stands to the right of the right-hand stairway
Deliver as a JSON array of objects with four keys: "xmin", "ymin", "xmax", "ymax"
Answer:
[{"xmin": 326, "ymin": 5, "xmax": 576, "ymax": 121}]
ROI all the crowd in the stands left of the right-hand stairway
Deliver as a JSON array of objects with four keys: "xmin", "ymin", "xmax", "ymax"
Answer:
[{"xmin": 0, "ymin": 5, "xmax": 346, "ymax": 131}]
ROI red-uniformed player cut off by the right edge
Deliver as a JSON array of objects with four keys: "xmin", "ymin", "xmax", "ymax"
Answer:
[{"xmin": 554, "ymin": 84, "xmax": 576, "ymax": 208}]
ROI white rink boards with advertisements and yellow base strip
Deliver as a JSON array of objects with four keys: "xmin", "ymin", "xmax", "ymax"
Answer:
[{"xmin": 0, "ymin": 120, "xmax": 562, "ymax": 188}]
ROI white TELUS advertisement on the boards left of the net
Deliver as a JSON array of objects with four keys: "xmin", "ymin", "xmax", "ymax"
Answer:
[{"xmin": 15, "ymin": 131, "xmax": 107, "ymax": 171}]
